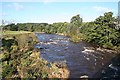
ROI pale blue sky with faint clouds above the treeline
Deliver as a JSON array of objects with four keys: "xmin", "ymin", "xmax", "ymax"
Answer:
[{"xmin": 0, "ymin": 0, "xmax": 118, "ymax": 24}]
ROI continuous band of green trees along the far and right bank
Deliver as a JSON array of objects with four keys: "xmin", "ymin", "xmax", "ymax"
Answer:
[{"xmin": 4, "ymin": 12, "xmax": 120, "ymax": 49}]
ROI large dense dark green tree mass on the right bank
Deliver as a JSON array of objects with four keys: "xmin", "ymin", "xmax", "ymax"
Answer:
[{"xmin": 80, "ymin": 12, "xmax": 120, "ymax": 48}]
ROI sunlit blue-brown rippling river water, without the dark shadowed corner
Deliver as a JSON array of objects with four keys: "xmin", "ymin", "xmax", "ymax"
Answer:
[{"xmin": 36, "ymin": 33, "xmax": 119, "ymax": 78}]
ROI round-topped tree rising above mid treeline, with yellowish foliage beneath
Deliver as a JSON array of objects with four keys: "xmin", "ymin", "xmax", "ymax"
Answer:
[{"xmin": 67, "ymin": 15, "xmax": 82, "ymax": 42}]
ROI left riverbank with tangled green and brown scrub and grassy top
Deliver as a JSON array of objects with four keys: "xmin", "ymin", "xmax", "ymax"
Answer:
[{"xmin": 0, "ymin": 31, "xmax": 68, "ymax": 79}]
